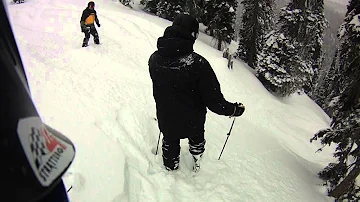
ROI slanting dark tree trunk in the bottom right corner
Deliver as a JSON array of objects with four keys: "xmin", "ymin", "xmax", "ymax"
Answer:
[{"xmin": 329, "ymin": 160, "xmax": 360, "ymax": 199}]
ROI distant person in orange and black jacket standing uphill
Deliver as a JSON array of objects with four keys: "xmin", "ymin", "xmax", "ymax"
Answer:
[{"xmin": 80, "ymin": 1, "xmax": 100, "ymax": 47}]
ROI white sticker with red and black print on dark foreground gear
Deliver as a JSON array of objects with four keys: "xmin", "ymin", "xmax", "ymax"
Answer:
[{"xmin": 17, "ymin": 117, "xmax": 75, "ymax": 187}]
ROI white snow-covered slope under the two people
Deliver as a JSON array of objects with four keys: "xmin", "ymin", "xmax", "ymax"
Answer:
[{"xmin": 8, "ymin": 0, "xmax": 338, "ymax": 202}]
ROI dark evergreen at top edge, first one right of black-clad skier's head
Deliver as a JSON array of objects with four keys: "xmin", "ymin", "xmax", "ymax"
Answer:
[{"xmin": 208, "ymin": 0, "xmax": 237, "ymax": 50}]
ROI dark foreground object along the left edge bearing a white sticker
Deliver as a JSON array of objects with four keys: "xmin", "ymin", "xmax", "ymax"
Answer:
[{"xmin": 0, "ymin": 0, "xmax": 75, "ymax": 202}]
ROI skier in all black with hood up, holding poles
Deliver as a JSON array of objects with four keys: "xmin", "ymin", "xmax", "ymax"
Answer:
[{"xmin": 148, "ymin": 14, "xmax": 245, "ymax": 172}]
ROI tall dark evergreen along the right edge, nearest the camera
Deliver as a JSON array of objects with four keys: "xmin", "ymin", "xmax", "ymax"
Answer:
[{"xmin": 311, "ymin": 0, "xmax": 360, "ymax": 201}]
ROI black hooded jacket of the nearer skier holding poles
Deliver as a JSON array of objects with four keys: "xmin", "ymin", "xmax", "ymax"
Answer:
[{"xmin": 149, "ymin": 25, "xmax": 235, "ymax": 139}]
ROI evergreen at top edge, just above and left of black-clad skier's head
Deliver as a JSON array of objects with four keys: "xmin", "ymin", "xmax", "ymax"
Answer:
[{"xmin": 156, "ymin": 0, "xmax": 186, "ymax": 21}]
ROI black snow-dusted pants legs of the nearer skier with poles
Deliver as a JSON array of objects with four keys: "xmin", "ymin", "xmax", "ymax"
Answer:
[{"xmin": 162, "ymin": 133, "xmax": 206, "ymax": 170}]
